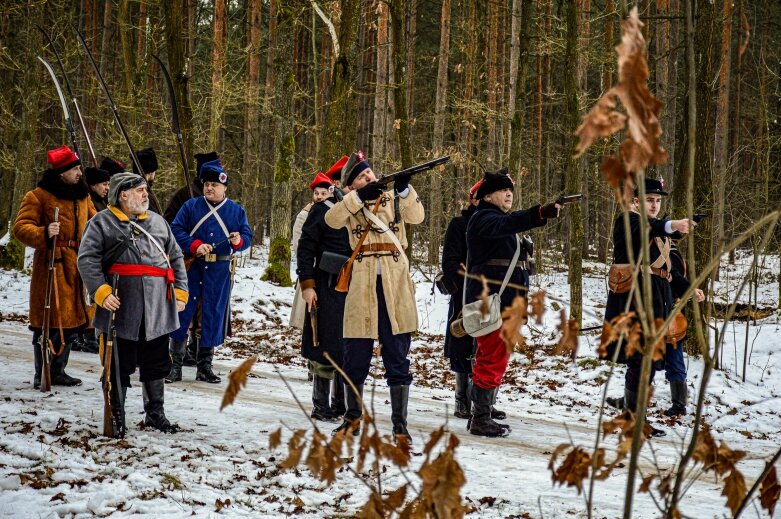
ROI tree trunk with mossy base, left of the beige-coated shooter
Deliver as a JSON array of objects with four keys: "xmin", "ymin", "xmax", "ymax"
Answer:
[{"xmin": 263, "ymin": 0, "xmax": 300, "ymax": 286}]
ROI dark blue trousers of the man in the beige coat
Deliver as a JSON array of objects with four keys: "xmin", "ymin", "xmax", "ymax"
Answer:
[{"xmin": 342, "ymin": 277, "xmax": 412, "ymax": 386}]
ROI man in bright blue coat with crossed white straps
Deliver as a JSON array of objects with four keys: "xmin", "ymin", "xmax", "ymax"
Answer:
[{"xmin": 166, "ymin": 160, "xmax": 252, "ymax": 384}]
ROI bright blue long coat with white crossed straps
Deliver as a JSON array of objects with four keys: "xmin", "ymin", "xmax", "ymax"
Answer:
[{"xmin": 171, "ymin": 197, "xmax": 252, "ymax": 348}]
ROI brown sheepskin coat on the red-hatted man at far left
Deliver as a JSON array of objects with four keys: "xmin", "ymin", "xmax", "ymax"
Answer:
[{"xmin": 13, "ymin": 170, "xmax": 95, "ymax": 329}]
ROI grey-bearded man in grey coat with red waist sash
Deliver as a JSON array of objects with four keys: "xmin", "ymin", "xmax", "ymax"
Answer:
[{"xmin": 78, "ymin": 173, "xmax": 188, "ymax": 437}]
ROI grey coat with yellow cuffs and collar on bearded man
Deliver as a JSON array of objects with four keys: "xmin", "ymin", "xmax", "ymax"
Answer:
[{"xmin": 78, "ymin": 205, "xmax": 188, "ymax": 341}]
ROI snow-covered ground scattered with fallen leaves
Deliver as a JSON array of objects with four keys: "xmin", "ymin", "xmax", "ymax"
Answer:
[{"xmin": 0, "ymin": 248, "xmax": 781, "ymax": 518}]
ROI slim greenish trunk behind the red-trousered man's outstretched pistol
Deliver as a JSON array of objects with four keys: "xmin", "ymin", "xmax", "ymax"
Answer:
[{"xmin": 563, "ymin": 2, "xmax": 583, "ymax": 324}]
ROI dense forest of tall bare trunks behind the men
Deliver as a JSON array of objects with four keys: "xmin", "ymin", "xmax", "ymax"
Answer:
[{"xmin": 0, "ymin": 0, "xmax": 781, "ymax": 318}]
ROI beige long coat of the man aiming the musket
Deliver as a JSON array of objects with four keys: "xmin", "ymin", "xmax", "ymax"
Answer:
[{"xmin": 325, "ymin": 186, "xmax": 425, "ymax": 339}]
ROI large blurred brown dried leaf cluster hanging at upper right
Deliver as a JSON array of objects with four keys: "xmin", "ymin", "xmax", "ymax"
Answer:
[{"xmin": 575, "ymin": 6, "xmax": 668, "ymax": 199}]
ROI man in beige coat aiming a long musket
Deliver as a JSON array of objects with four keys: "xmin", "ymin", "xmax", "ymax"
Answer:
[{"xmin": 325, "ymin": 152, "xmax": 425, "ymax": 440}]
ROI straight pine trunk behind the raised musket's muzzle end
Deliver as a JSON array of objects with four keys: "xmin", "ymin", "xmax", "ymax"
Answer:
[{"xmin": 428, "ymin": 0, "xmax": 450, "ymax": 265}]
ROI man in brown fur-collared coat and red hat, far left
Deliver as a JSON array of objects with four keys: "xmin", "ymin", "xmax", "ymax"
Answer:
[{"xmin": 13, "ymin": 146, "xmax": 95, "ymax": 389}]
